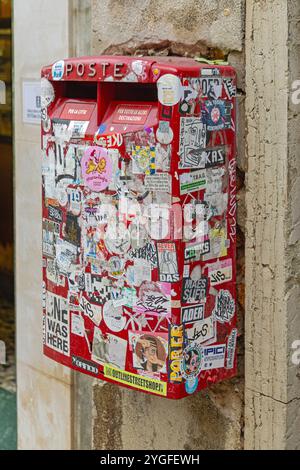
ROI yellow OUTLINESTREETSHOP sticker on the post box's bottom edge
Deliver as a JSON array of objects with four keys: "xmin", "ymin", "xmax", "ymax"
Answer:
[{"xmin": 104, "ymin": 364, "xmax": 167, "ymax": 396}]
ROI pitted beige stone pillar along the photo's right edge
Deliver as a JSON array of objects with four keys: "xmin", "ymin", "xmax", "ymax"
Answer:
[{"xmin": 245, "ymin": 0, "xmax": 300, "ymax": 449}]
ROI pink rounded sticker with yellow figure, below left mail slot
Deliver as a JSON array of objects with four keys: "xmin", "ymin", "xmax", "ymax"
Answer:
[{"xmin": 81, "ymin": 147, "xmax": 112, "ymax": 192}]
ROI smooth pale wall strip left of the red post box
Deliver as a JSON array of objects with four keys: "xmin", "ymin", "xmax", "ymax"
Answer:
[{"xmin": 14, "ymin": 0, "xmax": 72, "ymax": 449}]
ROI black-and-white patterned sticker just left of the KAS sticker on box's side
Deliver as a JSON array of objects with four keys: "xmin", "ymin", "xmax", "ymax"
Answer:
[{"xmin": 179, "ymin": 117, "xmax": 206, "ymax": 168}]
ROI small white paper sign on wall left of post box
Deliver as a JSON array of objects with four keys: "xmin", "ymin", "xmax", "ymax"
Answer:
[{"xmin": 23, "ymin": 80, "xmax": 41, "ymax": 125}]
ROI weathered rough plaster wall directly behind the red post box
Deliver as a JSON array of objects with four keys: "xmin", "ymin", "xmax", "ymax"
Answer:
[{"xmin": 92, "ymin": 0, "xmax": 247, "ymax": 450}]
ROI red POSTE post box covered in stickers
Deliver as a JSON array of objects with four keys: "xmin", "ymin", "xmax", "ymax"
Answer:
[{"xmin": 41, "ymin": 56, "xmax": 237, "ymax": 399}]
